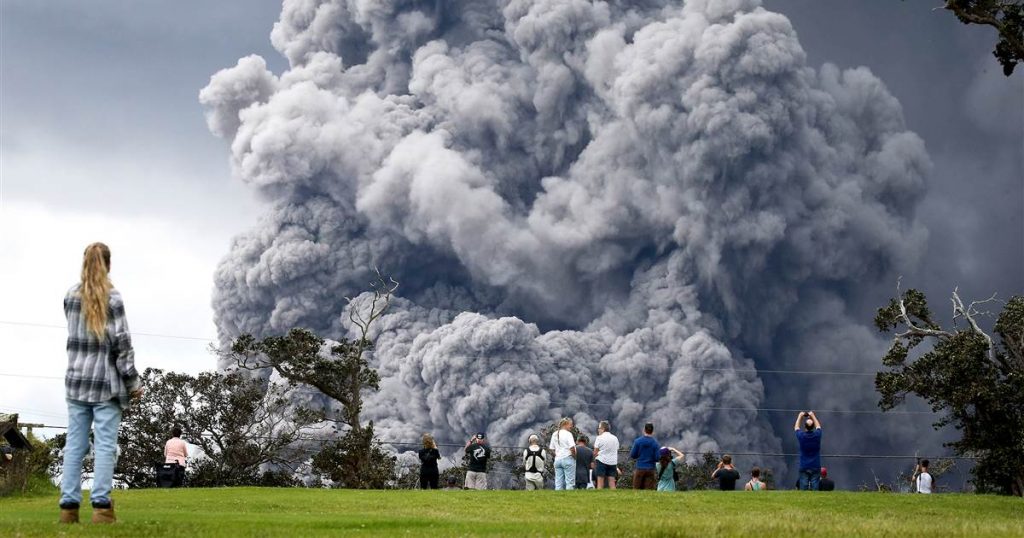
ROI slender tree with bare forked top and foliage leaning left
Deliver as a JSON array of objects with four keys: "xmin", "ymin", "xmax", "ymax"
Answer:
[{"xmin": 226, "ymin": 271, "xmax": 398, "ymax": 489}]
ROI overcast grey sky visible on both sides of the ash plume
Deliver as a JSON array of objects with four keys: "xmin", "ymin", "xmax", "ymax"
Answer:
[{"xmin": 0, "ymin": 0, "xmax": 1024, "ymax": 424}]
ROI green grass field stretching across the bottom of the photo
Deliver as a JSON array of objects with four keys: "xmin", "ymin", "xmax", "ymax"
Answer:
[{"xmin": 0, "ymin": 488, "xmax": 1024, "ymax": 538}]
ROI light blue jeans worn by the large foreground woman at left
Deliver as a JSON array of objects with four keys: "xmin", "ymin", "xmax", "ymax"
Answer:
[{"xmin": 60, "ymin": 400, "xmax": 121, "ymax": 506}]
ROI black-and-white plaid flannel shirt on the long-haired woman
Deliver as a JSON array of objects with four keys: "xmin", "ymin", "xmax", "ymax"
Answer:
[{"xmin": 65, "ymin": 285, "xmax": 141, "ymax": 407}]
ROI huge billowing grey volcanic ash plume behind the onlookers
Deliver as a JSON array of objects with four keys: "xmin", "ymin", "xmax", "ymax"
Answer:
[{"xmin": 200, "ymin": 0, "xmax": 929, "ymax": 469}]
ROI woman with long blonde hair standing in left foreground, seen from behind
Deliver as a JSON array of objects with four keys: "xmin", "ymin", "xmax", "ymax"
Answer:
[{"xmin": 60, "ymin": 243, "xmax": 142, "ymax": 523}]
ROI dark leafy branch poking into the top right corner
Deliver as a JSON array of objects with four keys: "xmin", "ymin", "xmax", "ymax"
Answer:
[{"xmin": 942, "ymin": 0, "xmax": 1024, "ymax": 77}]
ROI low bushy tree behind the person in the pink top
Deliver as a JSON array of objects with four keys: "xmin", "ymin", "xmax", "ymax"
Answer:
[{"xmin": 115, "ymin": 368, "xmax": 323, "ymax": 488}]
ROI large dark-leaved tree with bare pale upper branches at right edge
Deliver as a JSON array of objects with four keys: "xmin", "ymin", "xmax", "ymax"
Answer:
[{"xmin": 874, "ymin": 289, "xmax": 1024, "ymax": 495}]
